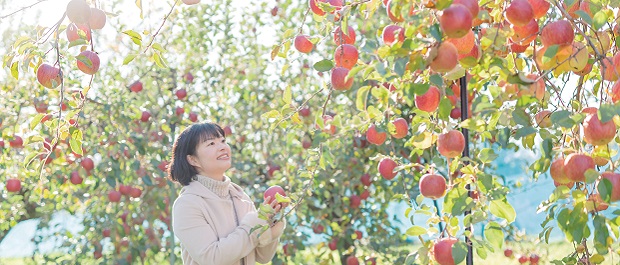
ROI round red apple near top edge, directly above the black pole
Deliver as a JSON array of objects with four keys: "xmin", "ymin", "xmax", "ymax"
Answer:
[{"xmin": 439, "ymin": 4, "xmax": 473, "ymax": 38}]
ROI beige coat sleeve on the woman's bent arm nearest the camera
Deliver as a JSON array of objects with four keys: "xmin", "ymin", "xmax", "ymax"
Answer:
[{"xmin": 172, "ymin": 194, "xmax": 260, "ymax": 264}]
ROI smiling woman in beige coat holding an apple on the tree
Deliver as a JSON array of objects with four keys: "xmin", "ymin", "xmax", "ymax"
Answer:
[{"xmin": 169, "ymin": 123, "xmax": 286, "ymax": 265}]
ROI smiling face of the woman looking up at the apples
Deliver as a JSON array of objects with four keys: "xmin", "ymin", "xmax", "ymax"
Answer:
[{"xmin": 187, "ymin": 137, "xmax": 231, "ymax": 178}]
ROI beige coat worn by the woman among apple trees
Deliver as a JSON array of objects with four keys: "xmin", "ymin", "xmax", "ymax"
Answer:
[{"xmin": 172, "ymin": 178, "xmax": 279, "ymax": 265}]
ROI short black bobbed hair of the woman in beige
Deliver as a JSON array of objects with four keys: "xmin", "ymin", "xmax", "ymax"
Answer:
[{"xmin": 168, "ymin": 122, "xmax": 226, "ymax": 186}]
